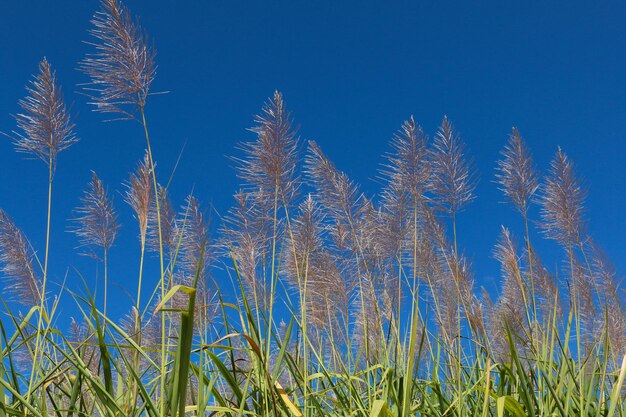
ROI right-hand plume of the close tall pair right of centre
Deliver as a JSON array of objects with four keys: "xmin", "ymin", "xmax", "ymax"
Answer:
[{"xmin": 431, "ymin": 116, "xmax": 477, "ymax": 213}]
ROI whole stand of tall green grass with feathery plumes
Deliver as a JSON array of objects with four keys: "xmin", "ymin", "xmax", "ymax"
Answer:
[{"xmin": 0, "ymin": 0, "xmax": 626, "ymax": 417}]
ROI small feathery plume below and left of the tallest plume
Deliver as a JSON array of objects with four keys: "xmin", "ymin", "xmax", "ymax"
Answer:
[{"xmin": 72, "ymin": 172, "xmax": 119, "ymax": 251}]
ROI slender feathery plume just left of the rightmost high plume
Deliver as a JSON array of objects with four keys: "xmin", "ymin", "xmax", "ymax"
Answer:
[{"xmin": 496, "ymin": 128, "xmax": 539, "ymax": 215}]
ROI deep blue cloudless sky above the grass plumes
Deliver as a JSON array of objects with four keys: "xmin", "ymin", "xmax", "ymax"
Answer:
[{"xmin": 0, "ymin": 0, "xmax": 626, "ymax": 312}]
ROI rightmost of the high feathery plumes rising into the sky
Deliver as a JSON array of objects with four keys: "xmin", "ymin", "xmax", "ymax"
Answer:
[{"xmin": 540, "ymin": 148, "xmax": 587, "ymax": 246}]
